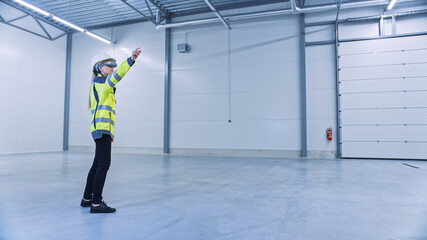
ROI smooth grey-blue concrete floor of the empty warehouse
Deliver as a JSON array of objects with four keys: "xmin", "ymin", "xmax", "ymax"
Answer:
[{"xmin": 0, "ymin": 152, "xmax": 427, "ymax": 240}]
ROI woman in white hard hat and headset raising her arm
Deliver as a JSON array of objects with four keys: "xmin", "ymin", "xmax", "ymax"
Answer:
[{"xmin": 80, "ymin": 48, "xmax": 141, "ymax": 213}]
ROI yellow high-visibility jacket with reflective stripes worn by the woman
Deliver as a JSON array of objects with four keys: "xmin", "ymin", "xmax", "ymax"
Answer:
[{"xmin": 90, "ymin": 58, "xmax": 134, "ymax": 140}]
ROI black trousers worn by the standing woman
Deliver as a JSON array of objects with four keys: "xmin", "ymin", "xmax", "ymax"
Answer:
[{"xmin": 83, "ymin": 134, "xmax": 111, "ymax": 204}]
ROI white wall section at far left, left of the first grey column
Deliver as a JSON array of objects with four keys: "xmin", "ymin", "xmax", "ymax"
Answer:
[{"xmin": 0, "ymin": 24, "xmax": 66, "ymax": 154}]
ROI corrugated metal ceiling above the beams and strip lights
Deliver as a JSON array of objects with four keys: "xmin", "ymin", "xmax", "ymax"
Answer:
[{"xmin": 0, "ymin": 0, "xmax": 425, "ymax": 34}]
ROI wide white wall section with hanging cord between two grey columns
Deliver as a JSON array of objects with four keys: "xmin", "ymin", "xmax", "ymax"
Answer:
[{"xmin": 171, "ymin": 16, "xmax": 301, "ymax": 150}]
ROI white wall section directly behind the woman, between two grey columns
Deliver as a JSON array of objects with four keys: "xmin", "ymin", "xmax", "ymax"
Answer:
[{"xmin": 69, "ymin": 23, "xmax": 165, "ymax": 148}]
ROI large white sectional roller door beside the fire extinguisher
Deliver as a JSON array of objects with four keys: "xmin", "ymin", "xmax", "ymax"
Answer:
[{"xmin": 338, "ymin": 36, "xmax": 427, "ymax": 159}]
